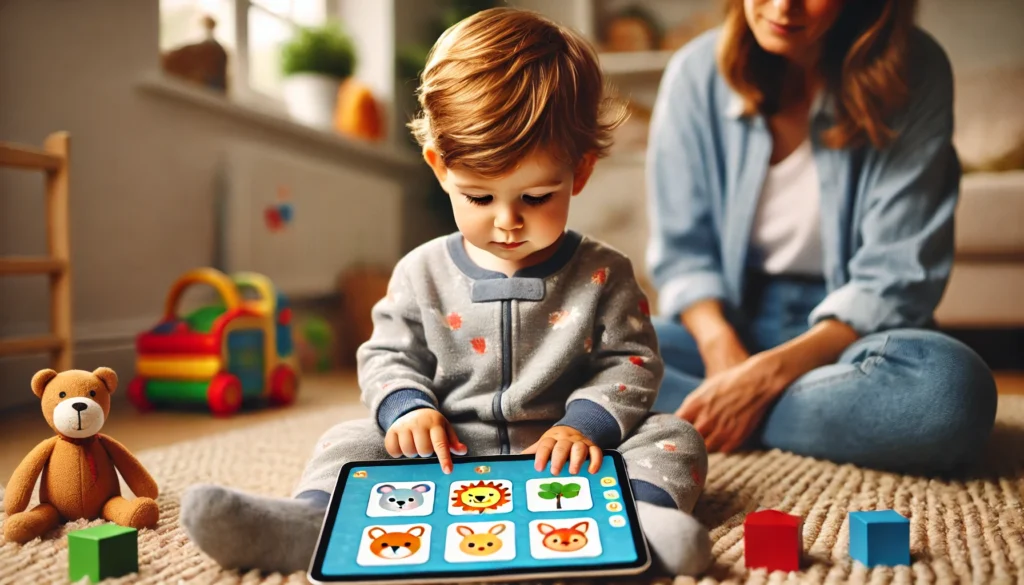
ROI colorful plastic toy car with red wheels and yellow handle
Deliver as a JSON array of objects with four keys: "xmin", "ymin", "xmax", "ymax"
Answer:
[{"xmin": 128, "ymin": 267, "xmax": 299, "ymax": 416}]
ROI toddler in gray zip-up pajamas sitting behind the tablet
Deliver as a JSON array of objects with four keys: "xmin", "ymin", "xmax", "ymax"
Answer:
[{"xmin": 181, "ymin": 8, "xmax": 711, "ymax": 575}]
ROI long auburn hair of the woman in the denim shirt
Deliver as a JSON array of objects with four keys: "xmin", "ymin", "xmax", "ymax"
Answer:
[{"xmin": 718, "ymin": 0, "xmax": 918, "ymax": 149}]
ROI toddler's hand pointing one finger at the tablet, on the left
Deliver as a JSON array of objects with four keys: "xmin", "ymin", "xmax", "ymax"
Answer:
[{"xmin": 384, "ymin": 408, "xmax": 468, "ymax": 473}]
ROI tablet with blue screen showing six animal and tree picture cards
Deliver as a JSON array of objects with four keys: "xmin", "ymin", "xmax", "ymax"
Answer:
[{"xmin": 307, "ymin": 450, "xmax": 650, "ymax": 584}]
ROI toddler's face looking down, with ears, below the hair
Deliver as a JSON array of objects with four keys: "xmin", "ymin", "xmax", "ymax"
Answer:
[{"xmin": 435, "ymin": 148, "xmax": 593, "ymax": 269}]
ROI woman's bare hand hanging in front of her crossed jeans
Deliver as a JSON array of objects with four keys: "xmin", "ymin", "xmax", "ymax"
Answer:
[{"xmin": 676, "ymin": 352, "xmax": 787, "ymax": 453}]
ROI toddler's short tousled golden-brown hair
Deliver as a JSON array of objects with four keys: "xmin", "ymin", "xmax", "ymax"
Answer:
[{"xmin": 409, "ymin": 7, "xmax": 627, "ymax": 176}]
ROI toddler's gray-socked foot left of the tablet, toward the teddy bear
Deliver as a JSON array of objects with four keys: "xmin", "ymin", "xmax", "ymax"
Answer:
[{"xmin": 181, "ymin": 486, "xmax": 327, "ymax": 574}]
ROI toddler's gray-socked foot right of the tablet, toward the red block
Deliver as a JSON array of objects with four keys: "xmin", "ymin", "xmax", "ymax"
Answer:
[{"xmin": 637, "ymin": 502, "xmax": 711, "ymax": 577}]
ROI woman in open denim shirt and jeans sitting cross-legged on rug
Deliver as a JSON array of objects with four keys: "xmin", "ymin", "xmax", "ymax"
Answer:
[{"xmin": 648, "ymin": 0, "xmax": 996, "ymax": 471}]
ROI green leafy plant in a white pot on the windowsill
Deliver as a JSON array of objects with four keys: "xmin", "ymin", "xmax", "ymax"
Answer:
[{"xmin": 281, "ymin": 24, "xmax": 355, "ymax": 128}]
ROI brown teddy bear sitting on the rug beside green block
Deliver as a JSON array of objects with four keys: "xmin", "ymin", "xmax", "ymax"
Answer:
[{"xmin": 3, "ymin": 368, "xmax": 160, "ymax": 544}]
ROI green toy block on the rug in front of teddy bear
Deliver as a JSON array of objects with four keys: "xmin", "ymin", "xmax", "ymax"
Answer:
[{"xmin": 68, "ymin": 524, "xmax": 138, "ymax": 583}]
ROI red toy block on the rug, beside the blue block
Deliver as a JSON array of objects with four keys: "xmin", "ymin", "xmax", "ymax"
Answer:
[{"xmin": 743, "ymin": 510, "xmax": 804, "ymax": 571}]
